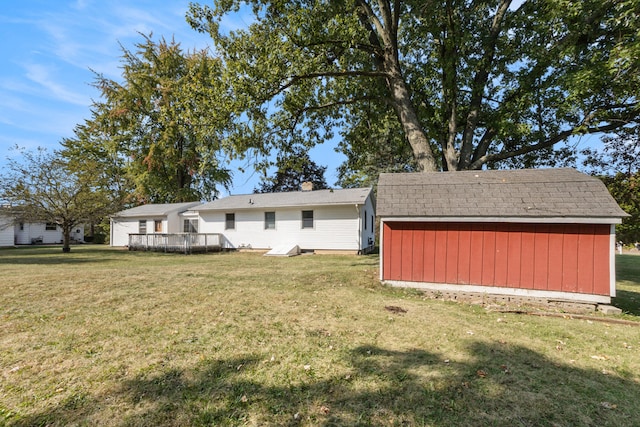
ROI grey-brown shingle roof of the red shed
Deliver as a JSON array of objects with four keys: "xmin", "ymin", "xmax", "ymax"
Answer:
[{"xmin": 377, "ymin": 168, "xmax": 628, "ymax": 219}]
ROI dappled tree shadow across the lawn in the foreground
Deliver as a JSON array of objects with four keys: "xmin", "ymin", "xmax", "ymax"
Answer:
[{"xmin": 10, "ymin": 341, "xmax": 640, "ymax": 426}]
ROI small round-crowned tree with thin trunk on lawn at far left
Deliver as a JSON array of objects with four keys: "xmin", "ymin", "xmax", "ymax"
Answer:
[{"xmin": 0, "ymin": 149, "xmax": 113, "ymax": 252}]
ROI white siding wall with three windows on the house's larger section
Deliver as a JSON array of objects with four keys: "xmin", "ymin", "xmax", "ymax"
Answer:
[{"xmin": 199, "ymin": 205, "xmax": 373, "ymax": 251}]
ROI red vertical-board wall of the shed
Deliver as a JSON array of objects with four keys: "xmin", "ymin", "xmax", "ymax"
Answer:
[{"xmin": 382, "ymin": 222, "xmax": 611, "ymax": 295}]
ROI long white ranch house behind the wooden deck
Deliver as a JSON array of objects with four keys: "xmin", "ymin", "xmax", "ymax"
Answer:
[{"xmin": 111, "ymin": 188, "xmax": 375, "ymax": 255}]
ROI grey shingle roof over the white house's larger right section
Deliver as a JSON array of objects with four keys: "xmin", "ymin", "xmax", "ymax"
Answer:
[{"xmin": 191, "ymin": 188, "xmax": 371, "ymax": 211}]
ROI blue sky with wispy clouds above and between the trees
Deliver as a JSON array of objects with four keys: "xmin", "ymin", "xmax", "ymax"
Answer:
[{"xmin": 0, "ymin": 0, "xmax": 343, "ymax": 194}]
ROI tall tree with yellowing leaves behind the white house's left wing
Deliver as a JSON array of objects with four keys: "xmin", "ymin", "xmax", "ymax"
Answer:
[{"xmin": 62, "ymin": 36, "xmax": 232, "ymax": 205}]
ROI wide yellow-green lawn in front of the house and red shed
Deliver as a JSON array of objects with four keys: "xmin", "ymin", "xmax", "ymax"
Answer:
[{"xmin": 0, "ymin": 246, "xmax": 640, "ymax": 426}]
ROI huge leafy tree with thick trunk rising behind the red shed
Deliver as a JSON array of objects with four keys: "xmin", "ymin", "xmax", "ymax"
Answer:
[{"xmin": 187, "ymin": 0, "xmax": 640, "ymax": 177}]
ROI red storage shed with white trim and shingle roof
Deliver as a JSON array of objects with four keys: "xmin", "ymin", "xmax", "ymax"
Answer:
[{"xmin": 377, "ymin": 168, "xmax": 628, "ymax": 304}]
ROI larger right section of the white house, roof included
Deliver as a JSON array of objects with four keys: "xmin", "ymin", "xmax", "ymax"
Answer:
[{"xmin": 191, "ymin": 188, "xmax": 375, "ymax": 253}]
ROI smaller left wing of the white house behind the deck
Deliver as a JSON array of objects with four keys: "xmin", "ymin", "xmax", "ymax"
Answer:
[{"xmin": 110, "ymin": 202, "xmax": 201, "ymax": 246}]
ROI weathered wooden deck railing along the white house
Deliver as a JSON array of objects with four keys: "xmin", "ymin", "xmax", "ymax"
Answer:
[{"xmin": 129, "ymin": 233, "xmax": 224, "ymax": 254}]
